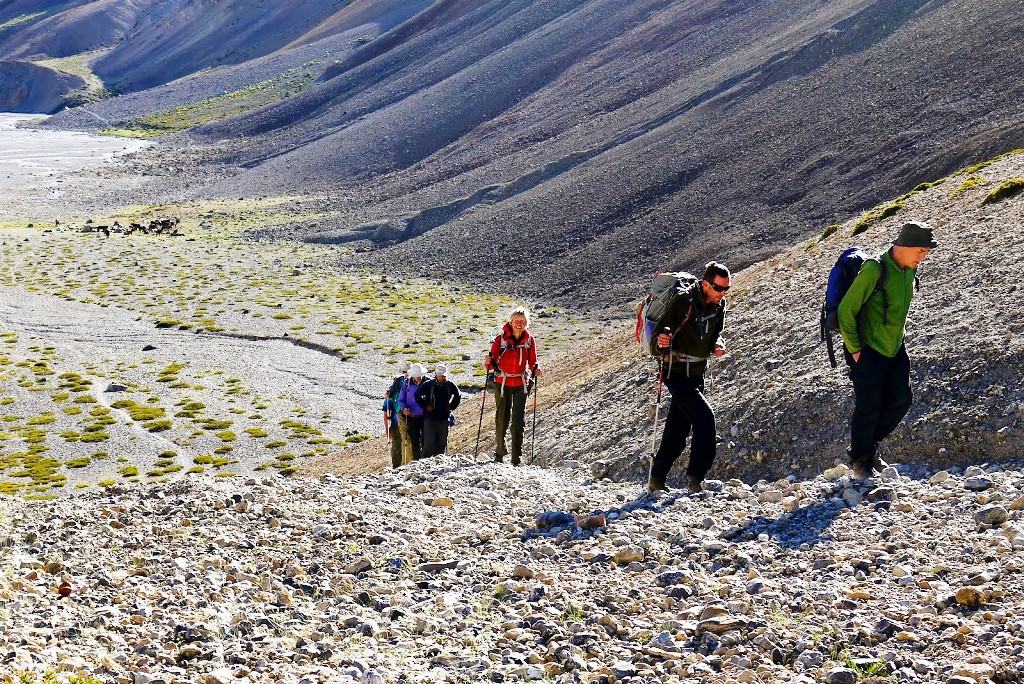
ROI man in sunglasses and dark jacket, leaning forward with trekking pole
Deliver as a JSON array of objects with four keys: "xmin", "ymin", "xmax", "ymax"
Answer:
[{"xmin": 647, "ymin": 261, "xmax": 731, "ymax": 493}]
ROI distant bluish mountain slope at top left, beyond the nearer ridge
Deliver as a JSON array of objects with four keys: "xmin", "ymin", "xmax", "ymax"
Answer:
[{"xmin": 0, "ymin": 0, "xmax": 430, "ymax": 112}]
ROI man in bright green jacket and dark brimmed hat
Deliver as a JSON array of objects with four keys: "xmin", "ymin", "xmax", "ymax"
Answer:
[{"xmin": 839, "ymin": 221, "xmax": 938, "ymax": 480}]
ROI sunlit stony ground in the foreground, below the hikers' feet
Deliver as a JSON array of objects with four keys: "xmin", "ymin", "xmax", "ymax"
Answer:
[{"xmin": 0, "ymin": 457, "xmax": 1024, "ymax": 684}]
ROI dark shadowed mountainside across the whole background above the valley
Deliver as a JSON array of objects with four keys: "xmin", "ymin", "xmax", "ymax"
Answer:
[{"xmin": 4, "ymin": 0, "xmax": 1024, "ymax": 306}]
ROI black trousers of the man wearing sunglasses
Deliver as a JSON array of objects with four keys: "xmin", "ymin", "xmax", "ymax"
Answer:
[{"xmin": 650, "ymin": 373, "xmax": 716, "ymax": 480}]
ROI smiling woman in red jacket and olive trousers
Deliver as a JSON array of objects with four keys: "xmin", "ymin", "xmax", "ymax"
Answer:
[{"xmin": 483, "ymin": 306, "xmax": 541, "ymax": 466}]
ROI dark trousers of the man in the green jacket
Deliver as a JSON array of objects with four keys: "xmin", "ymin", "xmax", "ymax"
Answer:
[{"xmin": 844, "ymin": 345, "xmax": 913, "ymax": 466}]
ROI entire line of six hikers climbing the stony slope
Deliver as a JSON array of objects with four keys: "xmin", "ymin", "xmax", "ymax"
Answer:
[{"xmin": 384, "ymin": 221, "xmax": 938, "ymax": 493}]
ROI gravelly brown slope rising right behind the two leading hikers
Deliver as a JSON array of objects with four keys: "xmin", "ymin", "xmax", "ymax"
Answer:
[{"xmin": 483, "ymin": 147, "xmax": 1024, "ymax": 484}]
